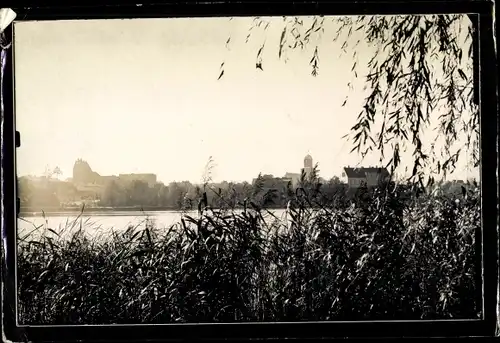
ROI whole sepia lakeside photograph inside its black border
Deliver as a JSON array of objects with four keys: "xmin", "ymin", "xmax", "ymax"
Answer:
[{"xmin": 13, "ymin": 14, "xmax": 482, "ymax": 325}]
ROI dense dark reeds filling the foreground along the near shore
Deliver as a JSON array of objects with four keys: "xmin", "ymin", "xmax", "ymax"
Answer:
[{"xmin": 17, "ymin": 180, "xmax": 480, "ymax": 324}]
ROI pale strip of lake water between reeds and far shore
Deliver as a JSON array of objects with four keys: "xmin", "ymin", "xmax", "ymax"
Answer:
[{"xmin": 17, "ymin": 210, "xmax": 285, "ymax": 241}]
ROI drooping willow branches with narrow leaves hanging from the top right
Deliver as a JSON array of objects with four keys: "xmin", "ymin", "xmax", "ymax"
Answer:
[{"xmin": 221, "ymin": 15, "xmax": 479, "ymax": 188}]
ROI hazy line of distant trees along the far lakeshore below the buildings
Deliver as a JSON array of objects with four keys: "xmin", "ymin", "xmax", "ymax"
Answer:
[{"xmin": 18, "ymin": 168, "xmax": 468, "ymax": 211}]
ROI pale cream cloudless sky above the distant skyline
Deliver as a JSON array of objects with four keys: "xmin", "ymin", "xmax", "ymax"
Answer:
[{"xmin": 15, "ymin": 17, "xmax": 477, "ymax": 183}]
